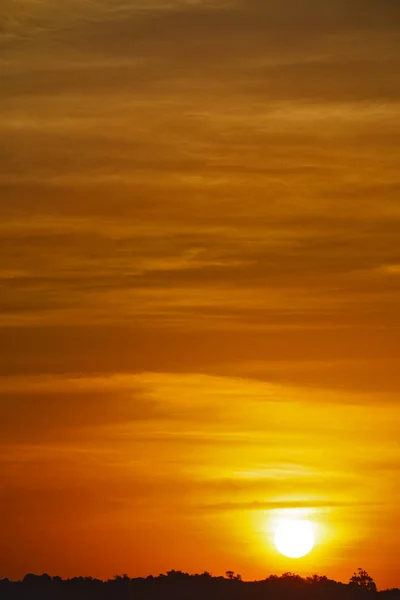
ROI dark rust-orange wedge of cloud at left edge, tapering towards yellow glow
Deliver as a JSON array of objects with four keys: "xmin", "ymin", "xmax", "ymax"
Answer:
[{"xmin": 0, "ymin": 377, "xmax": 165, "ymax": 444}]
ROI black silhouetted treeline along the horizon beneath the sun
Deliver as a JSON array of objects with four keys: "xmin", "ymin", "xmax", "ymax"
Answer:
[{"xmin": 0, "ymin": 569, "xmax": 400, "ymax": 600}]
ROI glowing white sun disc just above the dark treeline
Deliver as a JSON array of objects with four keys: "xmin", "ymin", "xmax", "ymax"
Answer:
[{"xmin": 275, "ymin": 519, "xmax": 315, "ymax": 558}]
